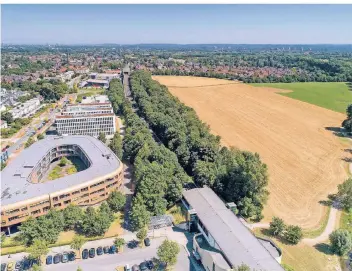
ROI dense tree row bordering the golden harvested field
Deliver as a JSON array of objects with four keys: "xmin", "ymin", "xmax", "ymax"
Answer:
[{"xmin": 126, "ymin": 71, "xmax": 268, "ymax": 219}]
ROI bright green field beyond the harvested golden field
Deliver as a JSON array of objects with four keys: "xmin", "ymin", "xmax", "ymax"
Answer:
[{"xmin": 250, "ymin": 82, "xmax": 352, "ymax": 113}]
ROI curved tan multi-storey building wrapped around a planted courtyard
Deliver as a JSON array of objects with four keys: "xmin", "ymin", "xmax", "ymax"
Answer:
[{"xmin": 1, "ymin": 136, "xmax": 123, "ymax": 234}]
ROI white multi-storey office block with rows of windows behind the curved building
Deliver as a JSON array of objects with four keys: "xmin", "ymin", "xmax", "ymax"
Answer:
[{"xmin": 55, "ymin": 103, "xmax": 116, "ymax": 137}]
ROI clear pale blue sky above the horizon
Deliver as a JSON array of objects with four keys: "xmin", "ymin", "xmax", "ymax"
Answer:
[{"xmin": 1, "ymin": 4, "xmax": 352, "ymax": 44}]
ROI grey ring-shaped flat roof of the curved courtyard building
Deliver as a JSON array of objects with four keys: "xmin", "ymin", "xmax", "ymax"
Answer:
[{"xmin": 1, "ymin": 135, "xmax": 121, "ymax": 206}]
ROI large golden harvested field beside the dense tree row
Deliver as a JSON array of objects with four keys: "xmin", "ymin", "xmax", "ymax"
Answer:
[{"xmin": 153, "ymin": 76, "xmax": 347, "ymax": 229}]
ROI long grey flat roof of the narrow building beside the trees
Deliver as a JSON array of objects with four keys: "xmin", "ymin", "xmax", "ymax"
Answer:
[{"xmin": 182, "ymin": 186, "xmax": 284, "ymax": 271}]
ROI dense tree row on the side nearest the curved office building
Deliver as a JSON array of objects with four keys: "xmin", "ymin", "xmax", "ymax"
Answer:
[{"xmin": 108, "ymin": 80, "xmax": 191, "ymax": 230}]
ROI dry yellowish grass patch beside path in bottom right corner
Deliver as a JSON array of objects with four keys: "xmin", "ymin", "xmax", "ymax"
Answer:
[{"xmin": 254, "ymin": 229, "xmax": 340, "ymax": 271}]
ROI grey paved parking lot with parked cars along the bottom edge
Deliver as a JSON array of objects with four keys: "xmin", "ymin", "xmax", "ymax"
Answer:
[{"xmin": 1, "ymin": 228, "xmax": 201, "ymax": 271}]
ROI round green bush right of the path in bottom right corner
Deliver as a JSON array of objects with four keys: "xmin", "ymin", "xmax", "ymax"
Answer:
[{"xmin": 329, "ymin": 229, "xmax": 352, "ymax": 256}]
